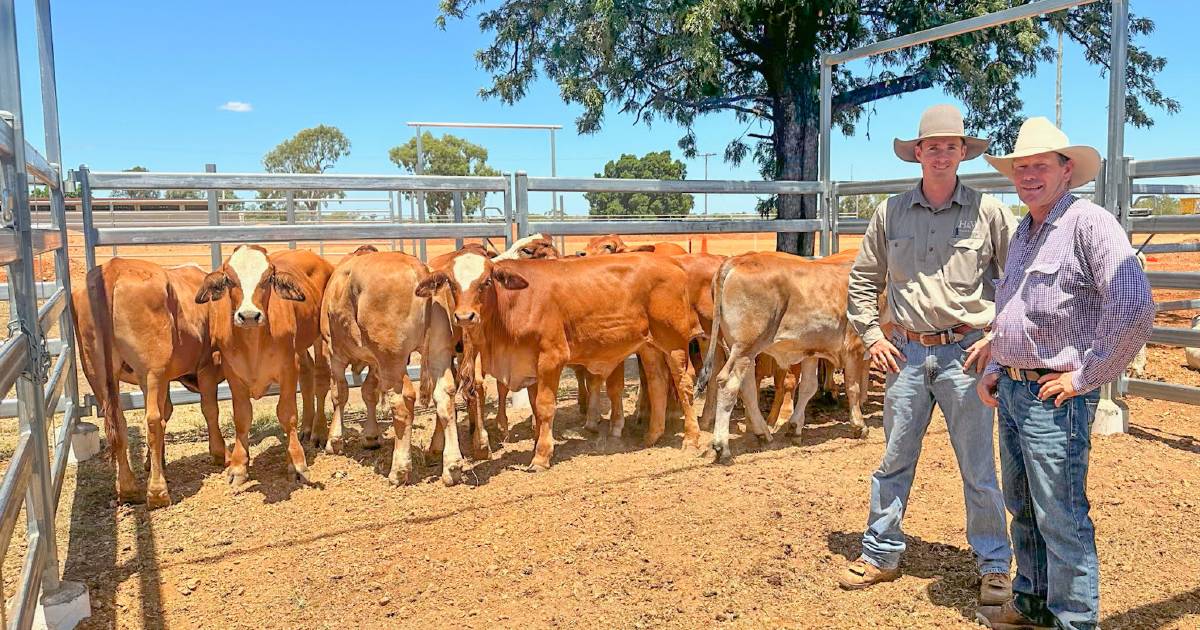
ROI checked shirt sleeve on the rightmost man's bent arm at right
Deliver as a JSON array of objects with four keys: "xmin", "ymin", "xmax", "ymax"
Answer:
[{"xmin": 1073, "ymin": 212, "xmax": 1156, "ymax": 394}]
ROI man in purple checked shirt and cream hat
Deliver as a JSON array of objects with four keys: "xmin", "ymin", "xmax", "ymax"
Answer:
[{"xmin": 978, "ymin": 118, "xmax": 1154, "ymax": 629}]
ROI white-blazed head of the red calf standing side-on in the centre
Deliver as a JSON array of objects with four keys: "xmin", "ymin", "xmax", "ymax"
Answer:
[{"xmin": 416, "ymin": 252, "xmax": 529, "ymax": 326}]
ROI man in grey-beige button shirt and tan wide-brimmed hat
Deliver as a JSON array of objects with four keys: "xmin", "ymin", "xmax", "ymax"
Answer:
[{"xmin": 839, "ymin": 104, "xmax": 1015, "ymax": 606}]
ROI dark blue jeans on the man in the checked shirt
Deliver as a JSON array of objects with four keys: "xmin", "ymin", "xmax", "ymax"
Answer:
[{"xmin": 996, "ymin": 374, "xmax": 1100, "ymax": 629}]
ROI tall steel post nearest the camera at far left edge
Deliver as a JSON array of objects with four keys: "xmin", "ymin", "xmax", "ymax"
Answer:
[{"xmin": 0, "ymin": 0, "xmax": 67, "ymax": 628}]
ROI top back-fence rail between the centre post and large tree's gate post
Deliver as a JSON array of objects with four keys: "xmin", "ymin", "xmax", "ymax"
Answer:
[{"xmin": 529, "ymin": 178, "xmax": 822, "ymax": 194}]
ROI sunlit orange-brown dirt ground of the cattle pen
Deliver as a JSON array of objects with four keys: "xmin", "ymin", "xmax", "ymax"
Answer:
[{"xmin": 0, "ymin": 232, "xmax": 1200, "ymax": 629}]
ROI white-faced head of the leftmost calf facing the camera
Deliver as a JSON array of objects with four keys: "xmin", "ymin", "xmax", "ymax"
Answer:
[{"xmin": 196, "ymin": 245, "xmax": 305, "ymax": 328}]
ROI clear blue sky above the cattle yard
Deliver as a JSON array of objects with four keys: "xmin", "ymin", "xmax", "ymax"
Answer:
[{"xmin": 11, "ymin": 0, "xmax": 1200, "ymax": 211}]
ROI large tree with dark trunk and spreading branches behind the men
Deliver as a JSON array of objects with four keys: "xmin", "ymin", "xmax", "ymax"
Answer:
[{"xmin": 438, "ymin": 0, "xmax": 1180, "ymax": 253}]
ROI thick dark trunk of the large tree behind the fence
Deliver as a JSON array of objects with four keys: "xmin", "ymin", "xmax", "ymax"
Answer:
[{"xmin": 774, "ymin": 79, "xmax": 821, "ymax": 256}]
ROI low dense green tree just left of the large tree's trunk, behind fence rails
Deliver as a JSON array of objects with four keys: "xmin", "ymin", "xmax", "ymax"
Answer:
[{"xmin": 583, "ymin": 151, "xmax": 695, "ymax": 216}]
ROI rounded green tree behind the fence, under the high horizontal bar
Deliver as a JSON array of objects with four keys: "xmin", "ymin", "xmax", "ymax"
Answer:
[{"xmin": 388, "ymin": 131, "xmax": 500, "ymax": 217}]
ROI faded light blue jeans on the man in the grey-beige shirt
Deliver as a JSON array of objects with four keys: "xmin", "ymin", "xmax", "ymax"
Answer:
[{"xmin": 863, "ymin": 332, "xmax": 1013, "ymax": 575}]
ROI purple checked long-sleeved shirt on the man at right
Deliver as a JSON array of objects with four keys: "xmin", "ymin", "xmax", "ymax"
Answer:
[{"xmin": 988, "ymin": 194, "xmax": 1154, "ymax": 394}]
